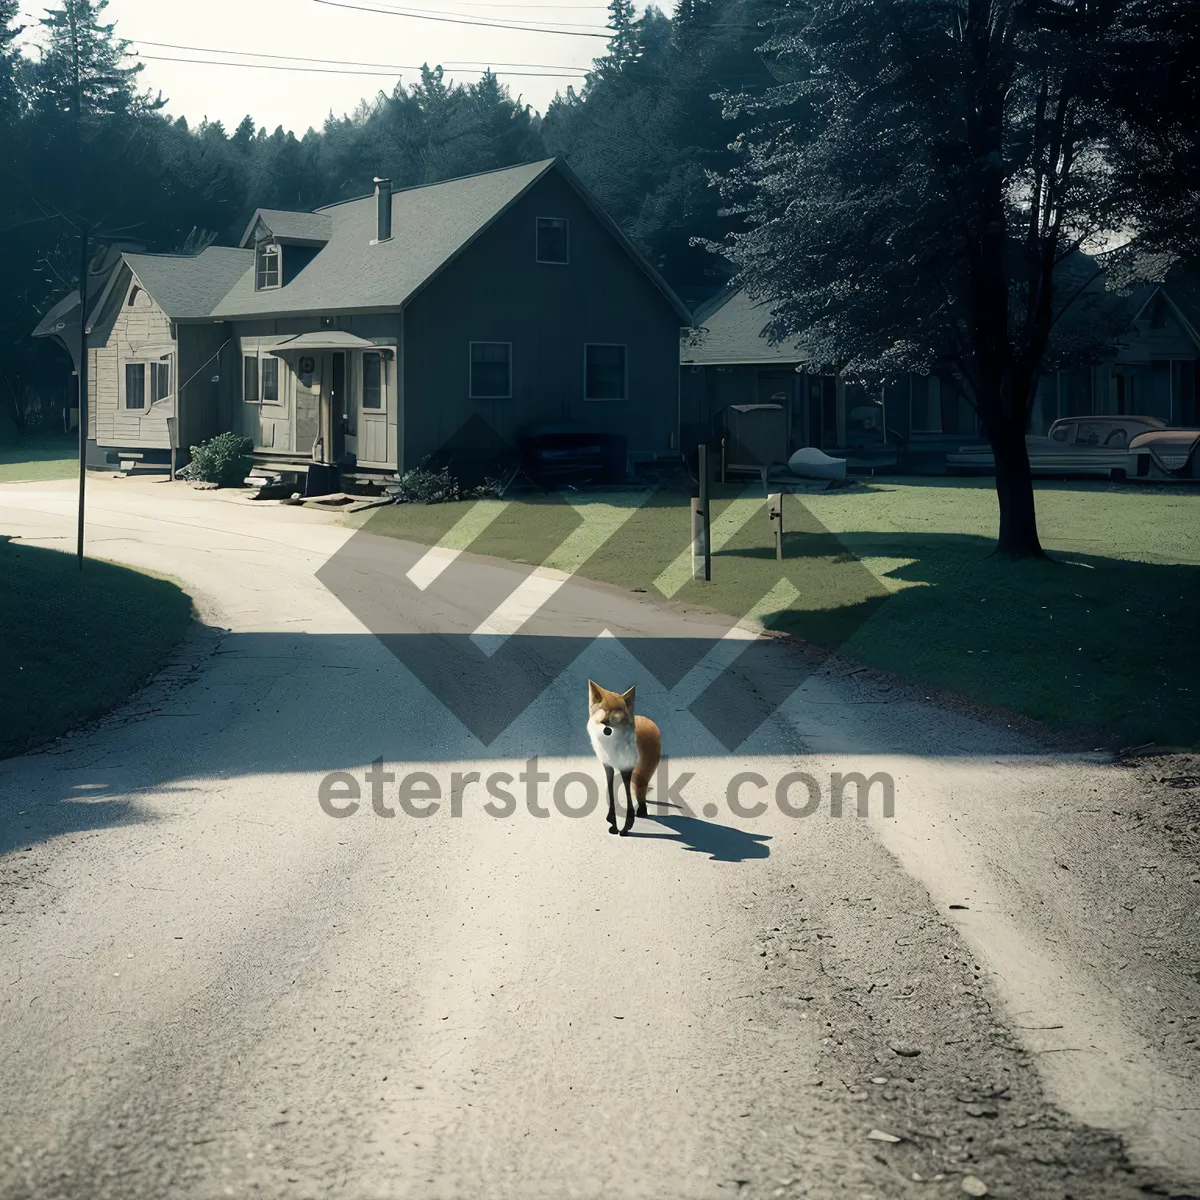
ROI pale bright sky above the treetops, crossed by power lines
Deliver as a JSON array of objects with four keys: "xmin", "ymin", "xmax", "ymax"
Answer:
[{"xmin": 11, "ymin": 0, "xmax": 641, "ymax": 136}]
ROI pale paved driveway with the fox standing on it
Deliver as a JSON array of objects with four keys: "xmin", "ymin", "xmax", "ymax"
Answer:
[{"xmin": 0, "ymin": 479, "xmax": 1200, "ymax": 1200}]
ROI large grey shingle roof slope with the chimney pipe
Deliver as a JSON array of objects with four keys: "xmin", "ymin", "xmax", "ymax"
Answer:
[{"xmin": 212, "ymin": 158, "xmax": 554, "ymax": 317}]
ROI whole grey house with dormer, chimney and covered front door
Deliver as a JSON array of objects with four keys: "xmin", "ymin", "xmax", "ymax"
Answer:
[{"xmin": 36, "ymin": 160, "xmax": 691, "ymax": 474}]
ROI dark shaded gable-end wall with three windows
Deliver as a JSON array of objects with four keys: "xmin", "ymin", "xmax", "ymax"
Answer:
[{"xmin": 395, "ymin": 172, "xmax": 682, "ymax": 467}]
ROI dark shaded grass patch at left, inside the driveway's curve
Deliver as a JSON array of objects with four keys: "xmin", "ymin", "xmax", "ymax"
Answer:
[{"xmin": 0, "ymin": 538, "xmax": 192, "ymax": 758}]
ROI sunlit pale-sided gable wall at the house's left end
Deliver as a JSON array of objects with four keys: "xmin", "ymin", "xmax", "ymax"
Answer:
[{"xmin": 88, "ymin": 272, "xmax": 179, "ymax": 450}]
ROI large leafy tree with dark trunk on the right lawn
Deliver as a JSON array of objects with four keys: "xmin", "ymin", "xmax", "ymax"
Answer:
[{"xmin": 722, "ymin": 0, "xmax": 1195, "ymax": 557}]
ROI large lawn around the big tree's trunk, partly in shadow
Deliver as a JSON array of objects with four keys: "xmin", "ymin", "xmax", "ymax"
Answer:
[{"xmin": 347, "ymin": 479, "xmax": 1200, "ymax": 748}]
